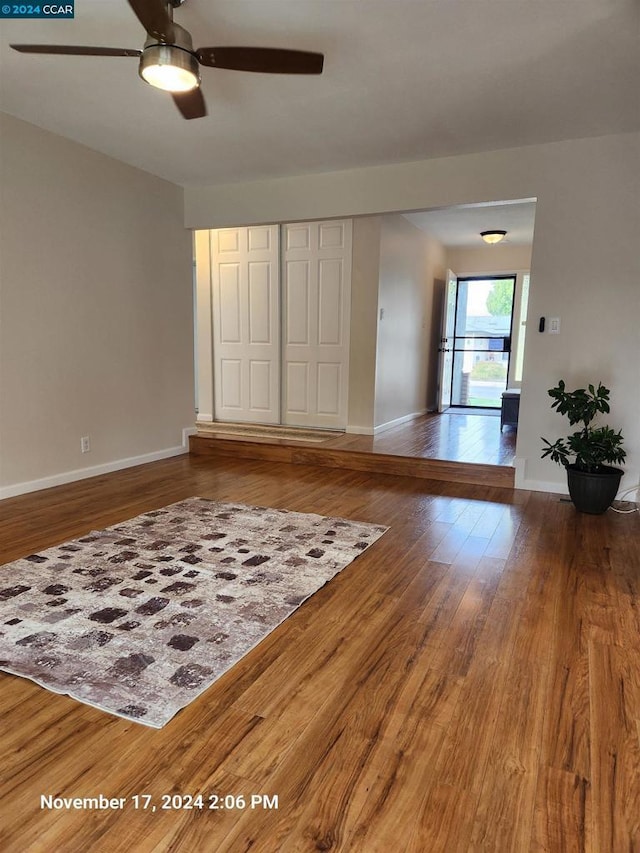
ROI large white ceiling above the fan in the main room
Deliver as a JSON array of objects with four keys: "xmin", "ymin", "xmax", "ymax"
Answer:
[{"xmin": 0, "ymin": 0, "xmax": 640, "ymax": 186}]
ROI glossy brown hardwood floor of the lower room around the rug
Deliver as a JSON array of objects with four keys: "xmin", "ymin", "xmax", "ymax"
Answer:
[{"xmin": 0, "ymin": 456, "xmax": 640, "ymax": 853}]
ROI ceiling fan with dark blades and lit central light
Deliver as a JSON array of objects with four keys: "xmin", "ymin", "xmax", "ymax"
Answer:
[{"xmin": 11, "ymin": 0, "xmax": 324, "ymax": 119}]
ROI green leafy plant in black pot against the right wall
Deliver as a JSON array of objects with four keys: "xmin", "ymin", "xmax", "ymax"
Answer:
[{"xmin": 542, "ymin": 379, "xmax": 627, "ymax": 514}]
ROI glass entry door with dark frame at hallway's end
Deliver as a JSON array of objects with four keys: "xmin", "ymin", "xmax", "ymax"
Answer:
[{"xmin": 451, "ymin": 275, "xmax": 516, "ymax": 408}]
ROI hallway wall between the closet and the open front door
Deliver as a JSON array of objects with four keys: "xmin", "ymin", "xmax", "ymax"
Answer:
[{"xmin": 375, "ymin": 214, "xmax": 444, "ymax": 426}]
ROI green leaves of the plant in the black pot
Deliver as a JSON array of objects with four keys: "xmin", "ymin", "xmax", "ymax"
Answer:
[{"xmin": 542, "ymin": 379, "xmax": 627, "ymax": 473}]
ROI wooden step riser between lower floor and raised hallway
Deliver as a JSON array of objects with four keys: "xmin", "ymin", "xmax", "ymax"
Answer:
[{"xmin": 189, "ymin": 435, "xmax": 515, "ymax": 489}]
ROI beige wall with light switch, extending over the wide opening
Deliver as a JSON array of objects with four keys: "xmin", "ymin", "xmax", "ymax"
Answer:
[{"xmin": 185, "ymin": 133, "xmax": 640, "ymax": 500}]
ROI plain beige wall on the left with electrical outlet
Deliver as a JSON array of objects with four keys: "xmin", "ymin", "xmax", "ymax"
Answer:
[{"xmin": 0, "ymin": 116, "xmax": 194, "ymax": 495}]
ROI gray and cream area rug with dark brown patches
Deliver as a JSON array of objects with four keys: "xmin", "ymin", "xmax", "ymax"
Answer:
[{"xmin": 0, "ymin": 498, "xmax": 387, "ymax": 728}]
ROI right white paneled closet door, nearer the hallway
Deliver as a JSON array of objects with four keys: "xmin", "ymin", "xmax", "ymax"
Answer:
[{"xmin": 282, "ymin": 220, "xmax": 352, "ymax": 429}]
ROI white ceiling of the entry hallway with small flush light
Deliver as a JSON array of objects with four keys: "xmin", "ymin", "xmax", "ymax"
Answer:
[{"xmin": 404, "ymin": 199, "xmax": 536, "ymax": 248}]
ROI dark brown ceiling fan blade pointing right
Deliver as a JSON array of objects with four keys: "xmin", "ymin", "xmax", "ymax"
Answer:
[{"xmin": 196, "ymin": 47, "xmax": 324, "ymax": 74}]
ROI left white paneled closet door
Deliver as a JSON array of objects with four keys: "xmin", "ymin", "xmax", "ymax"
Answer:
[{"xmin": 211, "ymin": 225, "xmax": 281, "ymax": 424}]
